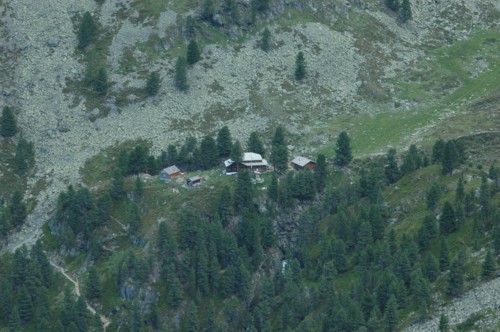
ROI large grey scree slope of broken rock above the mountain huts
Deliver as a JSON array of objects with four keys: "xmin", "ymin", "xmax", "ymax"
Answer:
[{"xmin": 0, "ymin": 0, "xmax": 497, "ymax": 249}]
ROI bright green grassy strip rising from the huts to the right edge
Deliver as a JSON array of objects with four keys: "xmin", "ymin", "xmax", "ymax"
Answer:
[{"xmin": 316, "ymin": 30, "xmax": 500, "ymax": 156}]
